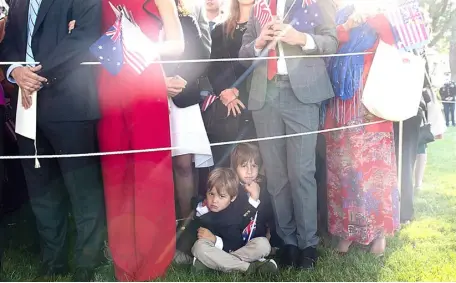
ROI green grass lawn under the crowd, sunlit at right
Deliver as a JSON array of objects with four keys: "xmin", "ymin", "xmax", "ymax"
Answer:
[{"xmin": 0, "ymin": 128, "xmax": 456, "ymax": 282}]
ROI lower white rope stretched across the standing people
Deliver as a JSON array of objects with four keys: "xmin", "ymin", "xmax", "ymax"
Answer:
[{"xmin": 0, "ymin": 120, "xmax": 388, "ymax": 160}]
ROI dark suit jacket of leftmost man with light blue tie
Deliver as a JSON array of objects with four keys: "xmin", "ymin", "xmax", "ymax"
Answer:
[{"xmin": 0, "ymin": 0, "xmax": 101, "ymax": 123}]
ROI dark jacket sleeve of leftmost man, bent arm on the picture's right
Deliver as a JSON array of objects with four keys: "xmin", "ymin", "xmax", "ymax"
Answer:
[{"xmin": 39, "ymin": 0, "xmax": 102, "ymax": 82}]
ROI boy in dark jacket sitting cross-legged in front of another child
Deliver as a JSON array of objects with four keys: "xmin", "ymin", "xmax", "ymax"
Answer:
[{"xmin": 177, "ymin": 168, "xmax": 277, "ymax": 273}]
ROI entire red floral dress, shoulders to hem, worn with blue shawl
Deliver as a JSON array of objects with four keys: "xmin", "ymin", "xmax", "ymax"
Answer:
[{"xmin": 325, "ymin": 15, "xmax": 399, "ymax": 245}]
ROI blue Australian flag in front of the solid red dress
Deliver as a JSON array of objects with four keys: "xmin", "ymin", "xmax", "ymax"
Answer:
[{"xmin": 90, "ymin": 19, "xmax": 123, "ymax": 75}]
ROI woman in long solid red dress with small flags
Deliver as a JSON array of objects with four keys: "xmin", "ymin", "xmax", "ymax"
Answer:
[{"xmin": 97, "ymin": 0, "xmax": 184, "ymax": 281}]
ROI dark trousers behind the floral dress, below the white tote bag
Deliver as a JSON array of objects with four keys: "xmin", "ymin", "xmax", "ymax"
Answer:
[{"xmin": 394, "ymin": 116, "xmax": 421, "ymax": 222}]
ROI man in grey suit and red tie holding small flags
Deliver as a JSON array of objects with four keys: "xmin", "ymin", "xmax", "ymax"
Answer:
[{"xmin": 239, "ymin": 0, "xmax": 338, "ymax": 269}]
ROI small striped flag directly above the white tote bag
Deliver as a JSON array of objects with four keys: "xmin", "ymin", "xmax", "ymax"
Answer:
[{"xmin": 387, "ymin": 0, "xmax": 429, "ymax": 50}]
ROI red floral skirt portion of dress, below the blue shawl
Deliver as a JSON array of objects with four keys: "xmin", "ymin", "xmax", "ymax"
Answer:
[{"xmin": 326, "ymin": 121, "xmax": 400, "ymax": 245}]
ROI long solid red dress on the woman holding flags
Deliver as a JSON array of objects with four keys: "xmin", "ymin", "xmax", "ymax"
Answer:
[{"xmin": 99, "ymin": 0, "xmax": 176, "ymax": 281}]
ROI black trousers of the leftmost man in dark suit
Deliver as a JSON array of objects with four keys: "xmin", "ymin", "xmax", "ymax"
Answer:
[{"xmin": 18, "ymin": 121, "xmax": 106, "ymax": 268}]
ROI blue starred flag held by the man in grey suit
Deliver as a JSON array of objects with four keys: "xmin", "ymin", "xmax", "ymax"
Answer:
[{"xmin": 290, "ymin": 0, "xmax": 323, "ymax": 33}]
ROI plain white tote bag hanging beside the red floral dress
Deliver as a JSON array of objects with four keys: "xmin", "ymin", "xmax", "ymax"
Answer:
[{"xmin": 362, "ymin": 41, "xmax": 425, "ymax": 122}]
